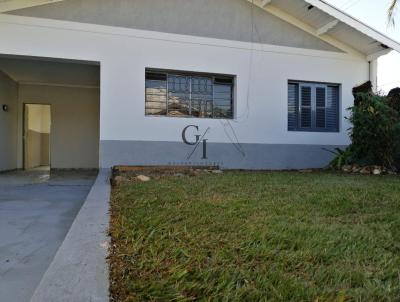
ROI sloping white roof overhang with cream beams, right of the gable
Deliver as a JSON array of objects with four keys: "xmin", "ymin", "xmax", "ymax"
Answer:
[{"xmin": 247, "ymin": 0, "xmax": 400, "ymax": 61}]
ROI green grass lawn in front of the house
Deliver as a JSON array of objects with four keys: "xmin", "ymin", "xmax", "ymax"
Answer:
[{"xmin": 110, "ymin": 172, "xmax": 400, "ymax": 301}]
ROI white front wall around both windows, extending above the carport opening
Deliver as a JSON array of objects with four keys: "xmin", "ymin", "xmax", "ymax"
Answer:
[{"xmin": 0, "ymin": 15, "xmax": 369, "ymax": 168}]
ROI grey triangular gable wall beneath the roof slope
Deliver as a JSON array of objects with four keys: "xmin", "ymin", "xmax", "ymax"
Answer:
[{"xmin": 9, "ymin": 0, "xmax": 342, "ymax": 52}]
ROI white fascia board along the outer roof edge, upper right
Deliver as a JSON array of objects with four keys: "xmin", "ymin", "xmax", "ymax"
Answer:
[{"xmin": 304, "ymin": 0, "xmax": 400, "ymax": 52}]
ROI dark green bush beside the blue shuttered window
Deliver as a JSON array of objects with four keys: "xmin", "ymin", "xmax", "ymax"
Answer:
[{"xmin": 349, "ymin": 93, "xmax": 400, "ymax": 168}]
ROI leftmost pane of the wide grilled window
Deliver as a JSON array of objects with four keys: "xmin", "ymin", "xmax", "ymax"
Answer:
[{"xmin": 146, "ymin": 74, "xmax": 167, "ymax": 115}]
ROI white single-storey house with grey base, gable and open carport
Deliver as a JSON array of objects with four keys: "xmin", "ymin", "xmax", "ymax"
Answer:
[{"xmin": 0, "ymin": 0, "xmax": 400, "ymax": 170}]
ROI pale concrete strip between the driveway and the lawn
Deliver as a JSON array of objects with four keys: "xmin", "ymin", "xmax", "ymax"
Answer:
[{"xmin": 31, "ymin": 169, "xmax": 111, "ymax": 302}]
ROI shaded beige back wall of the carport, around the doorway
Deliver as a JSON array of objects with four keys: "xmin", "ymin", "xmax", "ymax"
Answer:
[{"xmin": 18, "ymin": 85, "xmax": 100, "ymax": 169}]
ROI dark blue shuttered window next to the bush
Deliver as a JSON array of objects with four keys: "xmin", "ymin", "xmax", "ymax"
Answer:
[{"xmin": 288, "ymin": 82, "xmax": 339, "ymax": 132}]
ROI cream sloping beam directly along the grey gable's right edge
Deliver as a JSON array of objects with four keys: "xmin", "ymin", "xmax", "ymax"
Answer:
[{"xmin": 247, "ymin": 0, "xmax": 366, "ymax": 60}]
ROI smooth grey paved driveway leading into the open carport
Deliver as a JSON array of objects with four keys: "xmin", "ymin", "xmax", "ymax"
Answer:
[{"xmin": 0, "ymin": 172, "xmax": 96, "ymax": 302}]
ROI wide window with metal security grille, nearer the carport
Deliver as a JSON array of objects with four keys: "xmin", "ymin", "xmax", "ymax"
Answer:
[{"xmin": 146, "ymin": 70, "xmax": 234, "ymax": 119}]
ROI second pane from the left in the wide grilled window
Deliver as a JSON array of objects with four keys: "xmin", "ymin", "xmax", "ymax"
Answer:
[{"xmin": 168, "ymin": 75, "xmax": 190, "ymax": 116}]
